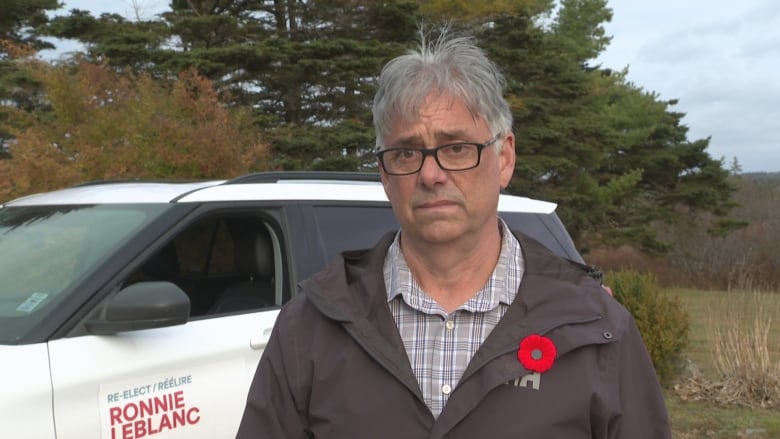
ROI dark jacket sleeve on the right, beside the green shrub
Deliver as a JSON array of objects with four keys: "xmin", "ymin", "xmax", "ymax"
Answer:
[{"xmin": 607, "ymin": 315, "xmax": 672, "ymax": 439}]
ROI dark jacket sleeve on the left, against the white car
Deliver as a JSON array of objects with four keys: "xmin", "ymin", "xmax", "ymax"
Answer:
[{"xmin": 236, "ymin": 308, "xmax": 311, "ymax": 439}]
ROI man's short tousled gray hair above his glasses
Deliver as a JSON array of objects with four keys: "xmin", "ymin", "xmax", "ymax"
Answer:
[{"xmin": 373, "ymin": 28, "xmax": 512, "ymax": 150}]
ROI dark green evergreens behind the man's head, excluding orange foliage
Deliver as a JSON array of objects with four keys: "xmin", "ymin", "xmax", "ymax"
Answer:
[{"xmin": 29, "ymin": 0, "xmax": 738, "ymax": 252}]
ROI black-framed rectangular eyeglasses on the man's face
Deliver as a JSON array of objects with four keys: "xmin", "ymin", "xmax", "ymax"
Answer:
[{"xmin": 376, "ymin": 134, "xmax": 499, "ymax": 175}]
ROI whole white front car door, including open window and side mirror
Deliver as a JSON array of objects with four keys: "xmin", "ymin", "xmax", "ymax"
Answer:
[{"xmin": 49, "ymin": 211, "xmax": 288, "ymax": 439}]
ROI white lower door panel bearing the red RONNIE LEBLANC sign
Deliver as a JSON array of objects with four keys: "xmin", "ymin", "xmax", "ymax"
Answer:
[{"xmin": 46, "ymin": 309, "xmax": 278, "ymax": 439}]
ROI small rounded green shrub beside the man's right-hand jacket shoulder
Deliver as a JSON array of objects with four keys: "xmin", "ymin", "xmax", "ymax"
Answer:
[{"xmin": 604, "ymin": 270, "xmax": 689, "ymax": 387}]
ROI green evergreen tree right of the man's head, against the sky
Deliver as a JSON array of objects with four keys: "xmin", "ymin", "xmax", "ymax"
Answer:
[{"xmin": 480, "ymin": 0, "xmax": 740, "ymax": 253}]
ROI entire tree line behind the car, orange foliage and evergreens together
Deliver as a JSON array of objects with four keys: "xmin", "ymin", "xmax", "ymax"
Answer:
[{"xmin": 0, "ymin": 0, "xmax": 745, "ymax": 254}]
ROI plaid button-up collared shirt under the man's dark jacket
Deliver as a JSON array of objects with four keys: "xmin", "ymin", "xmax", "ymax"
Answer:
[{"xmin": 384, "ymin": 219, "xmax": 524, "ymax": 417}]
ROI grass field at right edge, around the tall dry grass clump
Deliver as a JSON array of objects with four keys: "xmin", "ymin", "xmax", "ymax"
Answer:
[{"xmin": 666, "ymin": 289, "xmax": 780, "ymax": 439}]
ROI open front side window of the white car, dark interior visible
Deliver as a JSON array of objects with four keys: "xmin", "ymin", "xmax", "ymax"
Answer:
[{"xmin": 128, "ymin": 214, "xmax": 285, "ymax": 317}]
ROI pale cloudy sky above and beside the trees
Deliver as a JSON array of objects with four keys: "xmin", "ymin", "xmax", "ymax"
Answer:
[{"xmin": 59, "ymin": 0, "xmax": 780, "ymax": 172}]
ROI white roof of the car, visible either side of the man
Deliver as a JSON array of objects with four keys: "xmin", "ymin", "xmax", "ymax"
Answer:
[{"xmin": 6, "ymin": 172, "xmax": 556, "ymax": 214}]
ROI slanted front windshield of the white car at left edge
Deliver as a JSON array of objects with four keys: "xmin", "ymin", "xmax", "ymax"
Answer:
[{"xmin": 0, "ymin": 204, "xmax": 169, "ymax": 343}]
